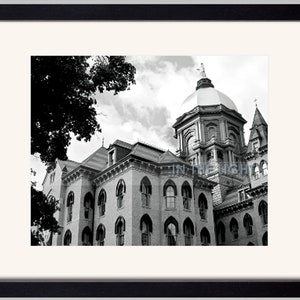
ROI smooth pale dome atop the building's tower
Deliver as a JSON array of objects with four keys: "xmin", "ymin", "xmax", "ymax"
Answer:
[{"xmin": 181, "ymin": 74, "xmax": 238, "ymax": 112}]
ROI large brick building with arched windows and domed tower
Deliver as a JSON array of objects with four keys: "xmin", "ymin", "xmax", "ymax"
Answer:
[{"xmin": 43, "ymin": 70, "xmax": 268, "ymax": 246}]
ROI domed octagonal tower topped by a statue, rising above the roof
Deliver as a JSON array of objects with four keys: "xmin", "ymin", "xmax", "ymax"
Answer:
[{"xmin": 173, "ymin": 64, "xmax": 247, "ymax": 204}]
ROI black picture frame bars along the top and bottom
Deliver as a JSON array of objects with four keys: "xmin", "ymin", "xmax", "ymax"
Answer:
[{"xmin": 0, "ymin": 4, "xmax": 300, "ymax": 297}]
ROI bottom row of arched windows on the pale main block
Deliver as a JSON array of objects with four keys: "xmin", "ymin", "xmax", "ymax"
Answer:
[{"xmin": 64, "ymin": 214, "xmax": 210, "ymax": 246}]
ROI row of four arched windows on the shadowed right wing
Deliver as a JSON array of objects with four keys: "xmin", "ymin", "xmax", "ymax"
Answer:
[{"xmin": 217, "ymin": 200, "xmax": 268, "ymax": 245}]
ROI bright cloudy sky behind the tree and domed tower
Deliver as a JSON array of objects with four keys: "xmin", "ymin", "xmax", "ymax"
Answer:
[{"xmin": 31, "ymin": 56, "xmax": 268, "ymax": 188}]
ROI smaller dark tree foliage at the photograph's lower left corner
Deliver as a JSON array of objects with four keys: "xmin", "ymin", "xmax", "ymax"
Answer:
[{"xmin": 31, "ymin": 186, "xmax": 59, "ymax": 245}]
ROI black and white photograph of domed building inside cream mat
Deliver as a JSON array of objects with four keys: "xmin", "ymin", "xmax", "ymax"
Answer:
[{"xmin": 28, "ymin": 55, "xmax": 269, "ymax": 246}]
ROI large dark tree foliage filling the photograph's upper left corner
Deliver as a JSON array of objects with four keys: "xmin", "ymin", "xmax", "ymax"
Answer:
[{"xmin": 31, "ymin": 56, "xmax": 136, "ymax": 164}]
